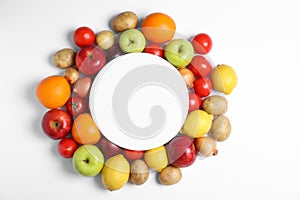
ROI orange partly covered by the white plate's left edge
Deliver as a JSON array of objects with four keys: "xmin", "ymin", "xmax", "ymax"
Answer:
[{"xmin": 72, "ymin": 113, "xmax": 101, "ymax": 144}]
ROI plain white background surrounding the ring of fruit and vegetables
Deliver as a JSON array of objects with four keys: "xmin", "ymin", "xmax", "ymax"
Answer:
[{"xmin": 0, "ymin": 0, "xmax": 300, "ymax": 200}]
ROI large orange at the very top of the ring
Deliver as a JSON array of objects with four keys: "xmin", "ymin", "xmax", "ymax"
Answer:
[{"xmin": 141, "ymin": 12, "xmax": 176, "ymax": 43}]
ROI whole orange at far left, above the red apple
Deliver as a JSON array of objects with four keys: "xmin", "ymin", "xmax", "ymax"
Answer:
[{"xmin": 35, "ymin": 75, "xmax": 71, "ymax": 109}]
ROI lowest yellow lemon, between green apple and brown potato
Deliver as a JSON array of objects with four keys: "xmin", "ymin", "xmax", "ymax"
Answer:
[{"xmin": 101, "ymin": 154, "xmax": 130, "ymax": 191}]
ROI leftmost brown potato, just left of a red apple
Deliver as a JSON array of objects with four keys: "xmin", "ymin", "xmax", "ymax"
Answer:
[{"xmin": 54, "ymin": 48, "xmax": 76, "ymax": 69}]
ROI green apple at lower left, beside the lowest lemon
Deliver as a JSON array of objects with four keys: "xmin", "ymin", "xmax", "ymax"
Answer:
[{"xmin": 72, "ymin": 144, "xmax": 104, "ymax": 176}]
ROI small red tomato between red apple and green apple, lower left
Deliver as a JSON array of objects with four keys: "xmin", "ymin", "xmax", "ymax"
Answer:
[{"xmin": 57, "ymin": 138, "xmax": 78, "ymax": 158}]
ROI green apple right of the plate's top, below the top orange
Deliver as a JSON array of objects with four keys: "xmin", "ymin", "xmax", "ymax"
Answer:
[{"xmin": 164, "ymin": 39, "xmax": 194, "ymax": 68}]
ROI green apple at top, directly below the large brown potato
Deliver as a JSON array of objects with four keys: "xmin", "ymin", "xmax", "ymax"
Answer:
[{"xmin": 119, "ymin": 29, "xmax": 146, "ymax": 53}]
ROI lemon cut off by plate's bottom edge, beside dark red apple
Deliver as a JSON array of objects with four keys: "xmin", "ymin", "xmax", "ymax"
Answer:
[{"xmin": 144, "ymin": 146, "xmax": 168, "ymax": 172}]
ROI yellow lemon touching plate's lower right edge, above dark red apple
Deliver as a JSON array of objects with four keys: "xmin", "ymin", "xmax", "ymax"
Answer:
[{"xmin": 181, "ymin": 110, "xmax": 214, "ymax": 138}]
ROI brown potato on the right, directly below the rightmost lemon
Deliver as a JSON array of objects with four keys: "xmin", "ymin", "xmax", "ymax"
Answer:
[{"xmin": 202, "ymin": 95, "xmax": 228, "ymax": 115}]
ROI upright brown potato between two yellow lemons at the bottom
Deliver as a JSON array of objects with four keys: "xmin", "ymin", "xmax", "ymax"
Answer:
[{"xmin": 129, "ymin": 159, "xmax": 149, "ymax": 185}]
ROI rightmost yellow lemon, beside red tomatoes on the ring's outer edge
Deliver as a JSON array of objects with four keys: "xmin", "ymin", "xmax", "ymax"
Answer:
[{"xmin": 211, "ymin": 64, "xmax": 238, "ymax": 95}]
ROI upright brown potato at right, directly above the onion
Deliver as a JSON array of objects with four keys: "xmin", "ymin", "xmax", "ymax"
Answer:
[{"xmin": 210, "ymin": 115, "xmax": 231, "ymax": 142}]
